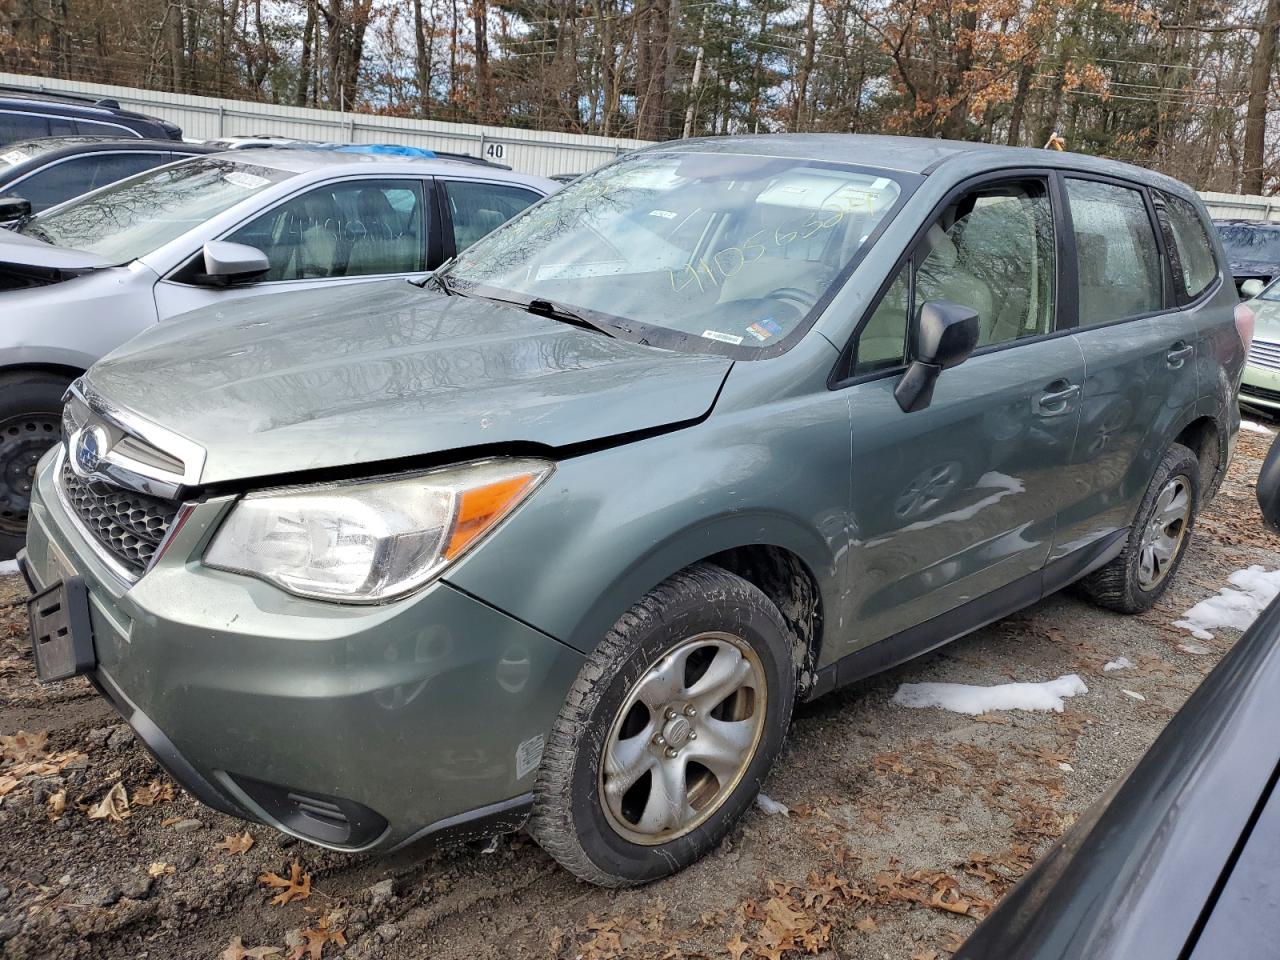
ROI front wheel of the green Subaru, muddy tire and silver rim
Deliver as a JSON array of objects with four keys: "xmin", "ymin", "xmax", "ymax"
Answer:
[{"xmin": 530, "ymin": 563, "xmax": 803, "ymax": 887}]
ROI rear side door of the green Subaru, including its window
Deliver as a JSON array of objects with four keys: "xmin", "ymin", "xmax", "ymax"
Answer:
[{"xmin": 1052, "ymin": 173, "xmax": 1199, "ymax": 559}]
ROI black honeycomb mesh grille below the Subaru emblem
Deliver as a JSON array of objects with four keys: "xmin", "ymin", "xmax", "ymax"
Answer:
[{"xmin": 61, "ymin": 462, "xmax": 179, "ymax": 576}]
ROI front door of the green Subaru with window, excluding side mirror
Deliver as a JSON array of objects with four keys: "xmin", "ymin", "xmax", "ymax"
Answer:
[{"xmin": 841, "ymin": 177, "xmax": 1084, "ymax": 653}]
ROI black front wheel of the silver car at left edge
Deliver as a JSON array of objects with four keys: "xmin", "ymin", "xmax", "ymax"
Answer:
[{"xmin": 0, "ymin": 370, "xmax": 70, "ymax": 559}]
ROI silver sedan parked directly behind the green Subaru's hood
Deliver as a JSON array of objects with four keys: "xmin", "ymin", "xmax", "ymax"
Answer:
[{"xmin": 0, "ymin": 150, "xmax": 558, "ymax": 558}]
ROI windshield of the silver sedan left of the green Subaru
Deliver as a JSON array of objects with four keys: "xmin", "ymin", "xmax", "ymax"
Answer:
[{"xmin": 18, "ymin": 156, "xmax": 293, "ymax": 264}]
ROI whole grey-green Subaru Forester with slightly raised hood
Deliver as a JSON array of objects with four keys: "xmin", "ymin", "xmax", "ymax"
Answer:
[{"xmin": 22, "ymin": 136, "xmax": 1253, "ymax": 886}]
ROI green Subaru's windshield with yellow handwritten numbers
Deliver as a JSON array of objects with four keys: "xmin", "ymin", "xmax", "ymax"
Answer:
[{"xmin": 445, "ymin": 152, "xmax": 902, "ymax": 348}]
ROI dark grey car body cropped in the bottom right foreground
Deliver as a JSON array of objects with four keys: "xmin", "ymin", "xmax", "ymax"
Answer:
[{"xmin": 952, "ymin": 591, "xmax": 1280, "ymax": 960}]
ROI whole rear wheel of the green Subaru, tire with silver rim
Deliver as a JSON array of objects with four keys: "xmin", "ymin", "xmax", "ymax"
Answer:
[{"xmin": 1080, "ymin": 443, "xmax": 1201, "ymax": 613}]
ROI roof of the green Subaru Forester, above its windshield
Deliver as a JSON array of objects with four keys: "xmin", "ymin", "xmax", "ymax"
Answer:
[{"xmin": 645, "ymin": 133, "xmax": 1193, "ymax": 195}]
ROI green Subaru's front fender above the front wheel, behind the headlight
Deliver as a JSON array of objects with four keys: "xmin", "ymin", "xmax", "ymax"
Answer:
[{"xmin": 445, "ymin": 394, "xmax": 850, "ymax": 653}]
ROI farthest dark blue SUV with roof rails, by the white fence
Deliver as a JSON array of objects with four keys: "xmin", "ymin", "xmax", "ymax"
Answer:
[{"xmin": 0, "ymin": 86, "xmax": 182, "ymax": 146}]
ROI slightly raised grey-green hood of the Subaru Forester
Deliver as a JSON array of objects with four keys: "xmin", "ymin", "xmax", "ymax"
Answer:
[{"xmin": 86, "ymin": 280, "xmax": 732, "ymax": 484}]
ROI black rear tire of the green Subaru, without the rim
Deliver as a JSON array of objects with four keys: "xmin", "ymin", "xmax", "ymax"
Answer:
[{"xmin": 1080, "ymin": 443, "xmax": 1201, "ymax": 613}]
